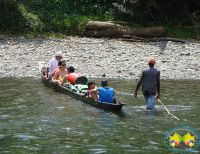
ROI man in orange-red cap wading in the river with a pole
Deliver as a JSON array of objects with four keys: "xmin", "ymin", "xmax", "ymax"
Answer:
[{"xmin": 134, "ymin": 58, "xmax": 160, "ymax": 110}]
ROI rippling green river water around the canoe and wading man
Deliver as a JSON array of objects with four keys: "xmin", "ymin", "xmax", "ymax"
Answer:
[{"xmin": 0, "ymin": 78, "xmax": 200, "ymax": 154}]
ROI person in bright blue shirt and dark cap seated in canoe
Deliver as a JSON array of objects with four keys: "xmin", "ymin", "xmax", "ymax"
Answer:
[{"xmin": 97, "ymin": 80, "xmax": 116, "ymax": 103}]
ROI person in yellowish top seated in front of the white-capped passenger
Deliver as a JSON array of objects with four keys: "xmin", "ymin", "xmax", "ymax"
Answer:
[{"xmin": 52, "ymin": 60, "xmax": 68, "ymax": 85}]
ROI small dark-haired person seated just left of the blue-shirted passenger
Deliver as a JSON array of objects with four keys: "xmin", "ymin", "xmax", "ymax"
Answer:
[{"xmin": 85, "ymin": 82, "xmax": 98, "ymax": 101}]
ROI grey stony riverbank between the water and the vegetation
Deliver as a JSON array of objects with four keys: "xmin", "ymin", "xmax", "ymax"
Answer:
[{"xmin": 0, "ymin": 36, "xmax": 200, "ymax": 79}]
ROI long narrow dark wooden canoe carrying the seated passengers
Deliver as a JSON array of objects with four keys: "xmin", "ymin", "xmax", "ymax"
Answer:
[{"xmin": 39, "ymin": 61, "xmax": 125, "ymax": 112}]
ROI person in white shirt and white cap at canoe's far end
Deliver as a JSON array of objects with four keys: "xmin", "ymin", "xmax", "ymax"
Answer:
[{"xmin": 45, "ymin": 51, "xmax": 63, "ymax": 78}]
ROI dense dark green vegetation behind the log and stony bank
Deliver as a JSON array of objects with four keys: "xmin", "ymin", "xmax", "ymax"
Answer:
[{"xmin": 0, "ymin": 0, "xmax": 200, "ymax": 38}]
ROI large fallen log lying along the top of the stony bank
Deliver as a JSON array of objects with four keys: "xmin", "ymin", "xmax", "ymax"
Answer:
[{"xmin": 85, "ymin": 21, "xmax": 165, "ymax": 38}]
